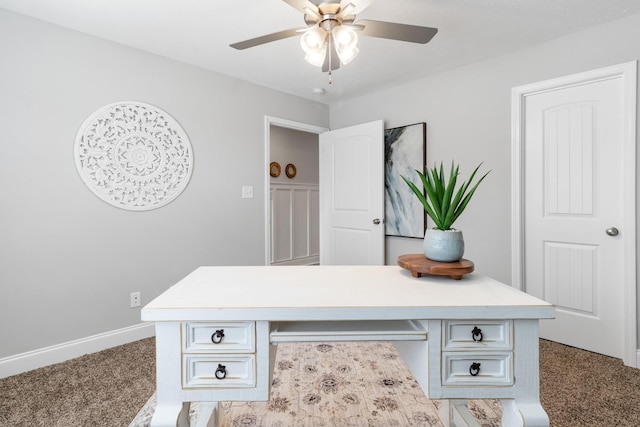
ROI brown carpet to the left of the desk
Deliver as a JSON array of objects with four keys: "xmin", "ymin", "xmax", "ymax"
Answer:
[{"xmin": 0, "ymin": 338, "xmax": 156, "ymax": 427}]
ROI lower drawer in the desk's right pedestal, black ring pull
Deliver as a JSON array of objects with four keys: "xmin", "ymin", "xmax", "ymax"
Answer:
[{"xmin": 442, "ymin": 352, "xmax": 513, "ymax": 386}]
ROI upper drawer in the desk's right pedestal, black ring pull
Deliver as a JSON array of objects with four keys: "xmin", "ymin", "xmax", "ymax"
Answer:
[{"xmin": 442, "ymin": 320, "xmax": 513, "ymax": 351}]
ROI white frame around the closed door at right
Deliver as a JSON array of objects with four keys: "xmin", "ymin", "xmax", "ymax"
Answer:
[{"xmin": 511, "ymin": 61, "xmax": 640, "ymax": 367}]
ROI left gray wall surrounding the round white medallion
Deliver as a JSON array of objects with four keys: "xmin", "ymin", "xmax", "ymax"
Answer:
[{"xmin": 0, "ymin": 10, "xmax": 329, "ymax": 358}]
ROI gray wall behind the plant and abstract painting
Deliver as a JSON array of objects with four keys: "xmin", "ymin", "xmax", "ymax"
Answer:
[{"xmin": 331, "ymin": 15, "xmax": 640, "ymax": 336}]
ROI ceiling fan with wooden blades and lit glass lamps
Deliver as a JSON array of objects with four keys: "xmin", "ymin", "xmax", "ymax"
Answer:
[{"xmin": 231, "ymin": 0, "xmax": 438, "ymax": 77}]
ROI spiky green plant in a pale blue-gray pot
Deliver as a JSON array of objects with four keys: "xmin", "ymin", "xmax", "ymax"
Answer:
[{"xmin": 402, "ymin": 161, "xmax": 491, "ymax": 262}]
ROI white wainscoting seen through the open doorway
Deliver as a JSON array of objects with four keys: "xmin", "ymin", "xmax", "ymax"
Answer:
[{"xmin": 271, "ymin": 183, "xmax": 320, "ymax": 265}]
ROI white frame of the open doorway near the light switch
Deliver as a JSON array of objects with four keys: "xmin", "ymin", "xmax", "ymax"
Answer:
[{"xmin": 264, "ymin": 116, "xmax": 329, "ymax": 265}]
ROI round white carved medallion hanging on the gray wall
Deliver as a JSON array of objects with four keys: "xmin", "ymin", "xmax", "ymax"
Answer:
[{"xmin": 75, "ymin": 102, "xmax": 193, "ymax": 211}]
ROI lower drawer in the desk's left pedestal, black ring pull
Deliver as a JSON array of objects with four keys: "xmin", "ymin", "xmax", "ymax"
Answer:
[{"xmin": 182, "ymin": 354, "xmax": 256, "ymax": 388}]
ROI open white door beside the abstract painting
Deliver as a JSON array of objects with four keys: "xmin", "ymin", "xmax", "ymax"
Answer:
[{"xmin": 319, "ymin": 120, "xmax": 384, "ymax": 265}]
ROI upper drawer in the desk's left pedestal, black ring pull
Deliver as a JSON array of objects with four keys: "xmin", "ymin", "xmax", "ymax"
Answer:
[{"xmin": 183, "ymin": 322, "xmax": 256, "ymax": 353}]
